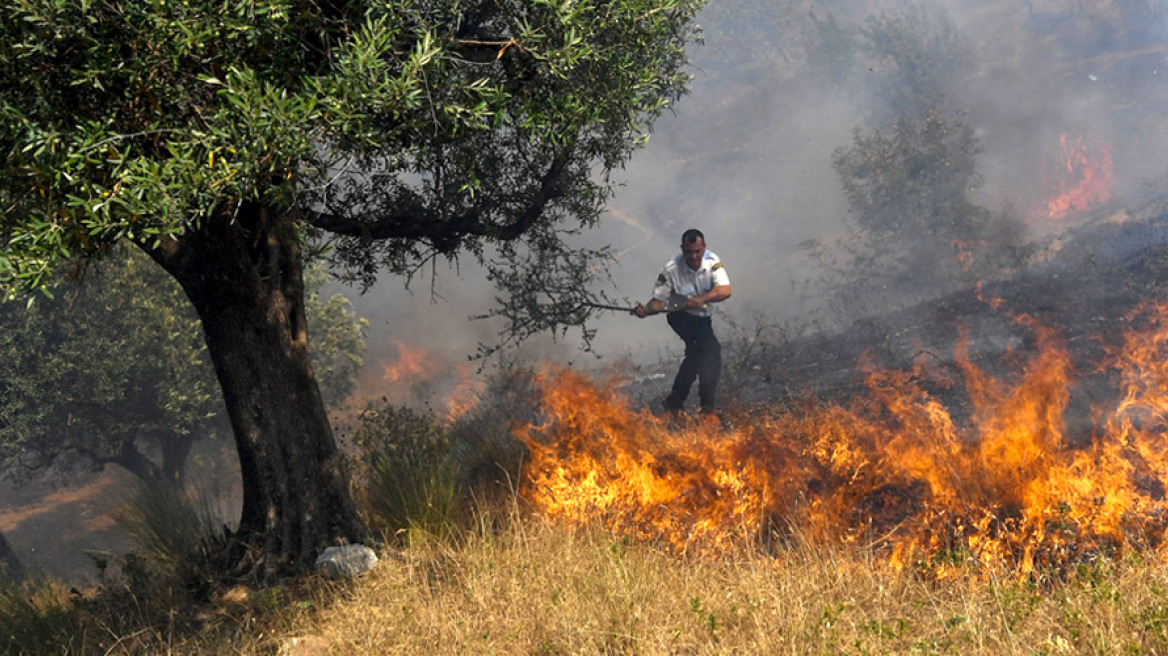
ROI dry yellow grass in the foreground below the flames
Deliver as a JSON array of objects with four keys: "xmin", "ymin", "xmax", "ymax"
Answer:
[{"xmin": 11, "ymin": 506, "xmax": 1168, "ymax": 656}]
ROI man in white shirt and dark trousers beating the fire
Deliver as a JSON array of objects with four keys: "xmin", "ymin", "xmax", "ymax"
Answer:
[{"xmin": 633, "ymin": 229, "xmax": 730, "ymax": 413}]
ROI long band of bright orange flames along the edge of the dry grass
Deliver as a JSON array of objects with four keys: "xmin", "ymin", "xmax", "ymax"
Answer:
[{"xmin": 521, "ymin": 305, "xmax": 1168, "ymax": 578}]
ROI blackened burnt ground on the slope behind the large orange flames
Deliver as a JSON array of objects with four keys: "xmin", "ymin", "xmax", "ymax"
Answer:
[{"xmin": 630, "ymin": 205, "xmax": 1168, "ymax": 439}]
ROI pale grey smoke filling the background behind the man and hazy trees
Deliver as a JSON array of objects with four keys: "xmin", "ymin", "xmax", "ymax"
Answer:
[{"xmin": 334, "ymin": 0, "xmax": 1168, "ymax": 406}]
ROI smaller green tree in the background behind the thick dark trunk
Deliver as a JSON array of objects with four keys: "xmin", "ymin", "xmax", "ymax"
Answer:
[{"xmin": 0, "ymin": 251, "xmax": 368, "ymax": 484}]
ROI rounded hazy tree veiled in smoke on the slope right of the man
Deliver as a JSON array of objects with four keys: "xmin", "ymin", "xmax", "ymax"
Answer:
[{"xmin": 805, "ymin": 107, "xmax": 1022, "ymax": 312}]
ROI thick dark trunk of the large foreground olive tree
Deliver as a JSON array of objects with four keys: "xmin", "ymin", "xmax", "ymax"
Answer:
[{"xmin": 150, "ymin": 204, "xmax": 366, "ymax": 580}]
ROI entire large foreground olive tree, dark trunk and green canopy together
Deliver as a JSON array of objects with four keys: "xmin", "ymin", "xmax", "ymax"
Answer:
[{"xmin": 0, "ymin": 0, "xmax": 701, "ymax": 579}]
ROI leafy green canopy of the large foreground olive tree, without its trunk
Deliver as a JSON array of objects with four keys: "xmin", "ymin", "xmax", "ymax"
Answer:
[{"xmin": 0, "ymin": 0, "xmax": 695, "ymax": 296}]
